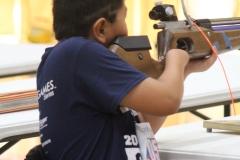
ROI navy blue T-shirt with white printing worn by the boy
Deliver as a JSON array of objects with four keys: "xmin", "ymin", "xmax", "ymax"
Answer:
[{"xmin": 37, "ymin": 37, "xmax": 148, "ymax": 160}]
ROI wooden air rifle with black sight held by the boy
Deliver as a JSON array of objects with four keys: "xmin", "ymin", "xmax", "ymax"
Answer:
[{"xmin": 109, "ymin": 0, "xmax": 240, "ymax": 78}]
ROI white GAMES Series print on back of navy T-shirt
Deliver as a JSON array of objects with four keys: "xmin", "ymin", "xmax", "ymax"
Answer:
[{"xmin": 38, "ymin": 80, "xmax": 57, "ymax": 100}]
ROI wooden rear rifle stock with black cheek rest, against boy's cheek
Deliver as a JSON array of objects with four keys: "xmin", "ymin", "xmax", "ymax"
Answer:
[{"xmin": 109, "ymin": 36, "xmax": 164, "ymax": 79}]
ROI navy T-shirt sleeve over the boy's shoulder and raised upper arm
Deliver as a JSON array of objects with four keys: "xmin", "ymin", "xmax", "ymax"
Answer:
[{"xmin": 76, "ymin": 41, "xmax": 148, "ymax": 113}]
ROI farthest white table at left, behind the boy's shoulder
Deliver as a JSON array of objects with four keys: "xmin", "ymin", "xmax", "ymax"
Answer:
[{"xmin": 0, "ymin": 44, "xmax": 53, "ymax": 77}]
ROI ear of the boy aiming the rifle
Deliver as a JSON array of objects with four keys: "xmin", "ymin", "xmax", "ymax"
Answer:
[{"xmin": 92, "ymin": 18, "xmax": 108, "ymax": 45}]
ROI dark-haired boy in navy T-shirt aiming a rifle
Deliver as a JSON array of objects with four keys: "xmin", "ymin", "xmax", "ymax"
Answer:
[{"xmin": 37, "ymin": 0, "xmax": 216, "ymax": 160}]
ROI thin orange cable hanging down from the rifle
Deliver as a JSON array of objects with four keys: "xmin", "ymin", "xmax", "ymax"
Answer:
[{"xmin": 193, "ymin": 22, "xmax": 236, "ymax": 116}]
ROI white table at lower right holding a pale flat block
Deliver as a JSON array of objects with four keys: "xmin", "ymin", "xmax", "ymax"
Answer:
[{"xmin": 155, "ymin": 116, "xmax": 240, "ymax": 160}]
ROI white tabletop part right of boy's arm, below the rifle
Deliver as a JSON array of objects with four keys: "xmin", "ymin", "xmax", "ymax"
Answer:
[{"xmin": 181, "ymin": 50, "xmax": 240, "ymax": 110}]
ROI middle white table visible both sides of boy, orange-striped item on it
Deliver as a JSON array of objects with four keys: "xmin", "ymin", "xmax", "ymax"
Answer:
[{"xmin": 0, "ymin": 51, "xmax": 240, "ymax": 155}]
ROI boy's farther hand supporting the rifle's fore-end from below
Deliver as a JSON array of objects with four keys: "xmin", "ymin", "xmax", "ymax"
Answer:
[{"xmin": 184, "ymin": 48, "xmax": 217, "ymax": 78}]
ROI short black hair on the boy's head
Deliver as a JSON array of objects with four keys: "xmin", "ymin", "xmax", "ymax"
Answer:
[{"xmin": 53, "ymin": 0, "xmax": 123, "ymax": 41}]
